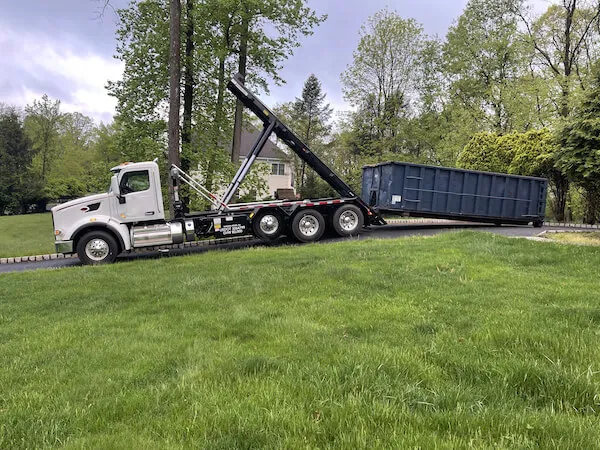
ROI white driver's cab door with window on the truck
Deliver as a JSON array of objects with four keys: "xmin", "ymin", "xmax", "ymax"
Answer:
[{"xmin": 117, "ymin": 170, "xmax": 162, "ymax": 222}]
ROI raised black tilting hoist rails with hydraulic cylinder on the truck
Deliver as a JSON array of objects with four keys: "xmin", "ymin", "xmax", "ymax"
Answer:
[{"xmin": 221, "ymin": 74, "xmax": 386, "ymax": 225}]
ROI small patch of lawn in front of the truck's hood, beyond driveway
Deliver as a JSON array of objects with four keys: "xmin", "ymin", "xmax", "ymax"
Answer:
[{"xmin": 0, "ymin": 213, "xmax": 54, "ymax": 258}]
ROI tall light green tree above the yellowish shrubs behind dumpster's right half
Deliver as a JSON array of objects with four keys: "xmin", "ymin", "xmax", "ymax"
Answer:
[{"xmin": 443, "ymin": 0, "xmax": 529, "ymax": 133}]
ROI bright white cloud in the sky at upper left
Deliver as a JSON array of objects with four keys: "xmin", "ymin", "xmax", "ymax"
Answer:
[{"xmin": 0, "ymin": 23, "xmax": 123, "ymax": 122}]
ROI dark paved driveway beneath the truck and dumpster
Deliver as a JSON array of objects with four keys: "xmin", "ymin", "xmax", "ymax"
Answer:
[{"xmin": 0, "ymin": 222, "xmax": 560, "ymax": 273}]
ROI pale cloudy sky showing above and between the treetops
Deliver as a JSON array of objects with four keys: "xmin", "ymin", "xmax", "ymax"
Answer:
[{"xmin": 0, "ymin": 0, "xmax": 474, "ymax": 123}]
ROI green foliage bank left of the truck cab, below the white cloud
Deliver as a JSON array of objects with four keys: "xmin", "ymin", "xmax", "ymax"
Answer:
[{"xmin": 0, "ymin": 95, "xmax": 123, "ymax": 213}]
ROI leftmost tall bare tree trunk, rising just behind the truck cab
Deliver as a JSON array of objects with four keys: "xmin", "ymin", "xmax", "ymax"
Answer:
[{"xmin": 167, "ymin": 0, "xmax": 181, "ymax": 218}]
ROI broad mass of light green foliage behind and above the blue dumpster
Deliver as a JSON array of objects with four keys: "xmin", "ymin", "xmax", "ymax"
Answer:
[{"xmin": 332, "ymin": 0, "xmax": 600, "ymax": 174}]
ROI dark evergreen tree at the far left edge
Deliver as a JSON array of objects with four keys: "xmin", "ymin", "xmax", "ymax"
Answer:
[{"xmin": 0, "ymin": 108, "xmax": 35, "ymax": 215}]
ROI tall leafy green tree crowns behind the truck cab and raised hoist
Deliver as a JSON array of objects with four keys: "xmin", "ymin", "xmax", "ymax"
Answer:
[{"xmin": 109, "ymin": 0, "xmax": 324, "ymax": 206}]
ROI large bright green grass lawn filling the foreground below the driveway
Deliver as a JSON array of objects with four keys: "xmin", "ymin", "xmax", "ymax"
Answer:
[{"xmin": 0, "ymin": 232, "xmax": 600, "ymax": 449}]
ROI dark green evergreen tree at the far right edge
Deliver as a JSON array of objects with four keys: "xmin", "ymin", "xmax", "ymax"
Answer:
[{"xmin": 558, "ymin": 63, "xmax": 600, "ymax": 224}]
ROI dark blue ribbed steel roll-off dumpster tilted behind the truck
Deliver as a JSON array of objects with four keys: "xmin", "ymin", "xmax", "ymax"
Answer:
[{"xmin": 361, "ymin": 162, "xmax": 548, "ymax": 227}]
